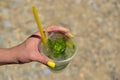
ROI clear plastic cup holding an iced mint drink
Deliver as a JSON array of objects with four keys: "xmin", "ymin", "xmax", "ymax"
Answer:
[{"xmin": 38, "ymin": 32, "xmax": 77, "ymax": 71}]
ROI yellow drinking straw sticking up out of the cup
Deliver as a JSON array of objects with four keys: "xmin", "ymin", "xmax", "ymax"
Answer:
[{"xmin": 32, "ymin": 6, "xmax": 47, "ymax": 46}]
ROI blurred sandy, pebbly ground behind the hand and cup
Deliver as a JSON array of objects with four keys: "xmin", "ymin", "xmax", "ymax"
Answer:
[{"xmin": 0, "ymin": 0, "xmax": 120, "ymax": 80}]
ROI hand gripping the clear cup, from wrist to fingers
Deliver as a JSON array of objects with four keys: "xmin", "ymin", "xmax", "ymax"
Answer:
[{"xmin": 16, "ymin": 26, "xmax": 72, "ymax": 64}]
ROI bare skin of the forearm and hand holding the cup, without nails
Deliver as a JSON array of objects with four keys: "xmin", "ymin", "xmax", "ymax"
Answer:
[{"xmin": 0, "ymin": 26, "xmax": 72, "ymax": 65}]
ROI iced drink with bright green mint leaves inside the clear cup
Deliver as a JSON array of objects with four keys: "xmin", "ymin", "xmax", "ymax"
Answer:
[{"xmin": 48, "ymin": 33, "xmax": 75, "ymax": 60}]
